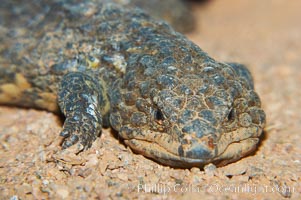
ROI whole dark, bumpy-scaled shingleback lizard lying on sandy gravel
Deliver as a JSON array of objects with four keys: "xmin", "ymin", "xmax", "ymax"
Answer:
[{"xmin": 0, "ymin": 0, "xmax": 265, "ymax": 168}]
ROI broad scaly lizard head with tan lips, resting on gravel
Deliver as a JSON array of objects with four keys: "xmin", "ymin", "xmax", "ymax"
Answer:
[{"xmin": 110, "ymin": 49, "xmax": 265, "ymax": 167}]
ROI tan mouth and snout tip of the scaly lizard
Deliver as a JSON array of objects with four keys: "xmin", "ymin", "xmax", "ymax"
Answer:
[{"xmin": 124, "ymin": 127, "xmax": 261, "ymax": 168}]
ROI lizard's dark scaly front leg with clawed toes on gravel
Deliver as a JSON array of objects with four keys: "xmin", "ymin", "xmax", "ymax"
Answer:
[{"xmin": 58, "ymin": 72, "xmax": 109, "ymax": 151}]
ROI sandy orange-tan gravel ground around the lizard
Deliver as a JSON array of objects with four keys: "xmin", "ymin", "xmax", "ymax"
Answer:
[{"xmin": 0, "ymin": 0, "xmax": 301, "ymax": 199}]
